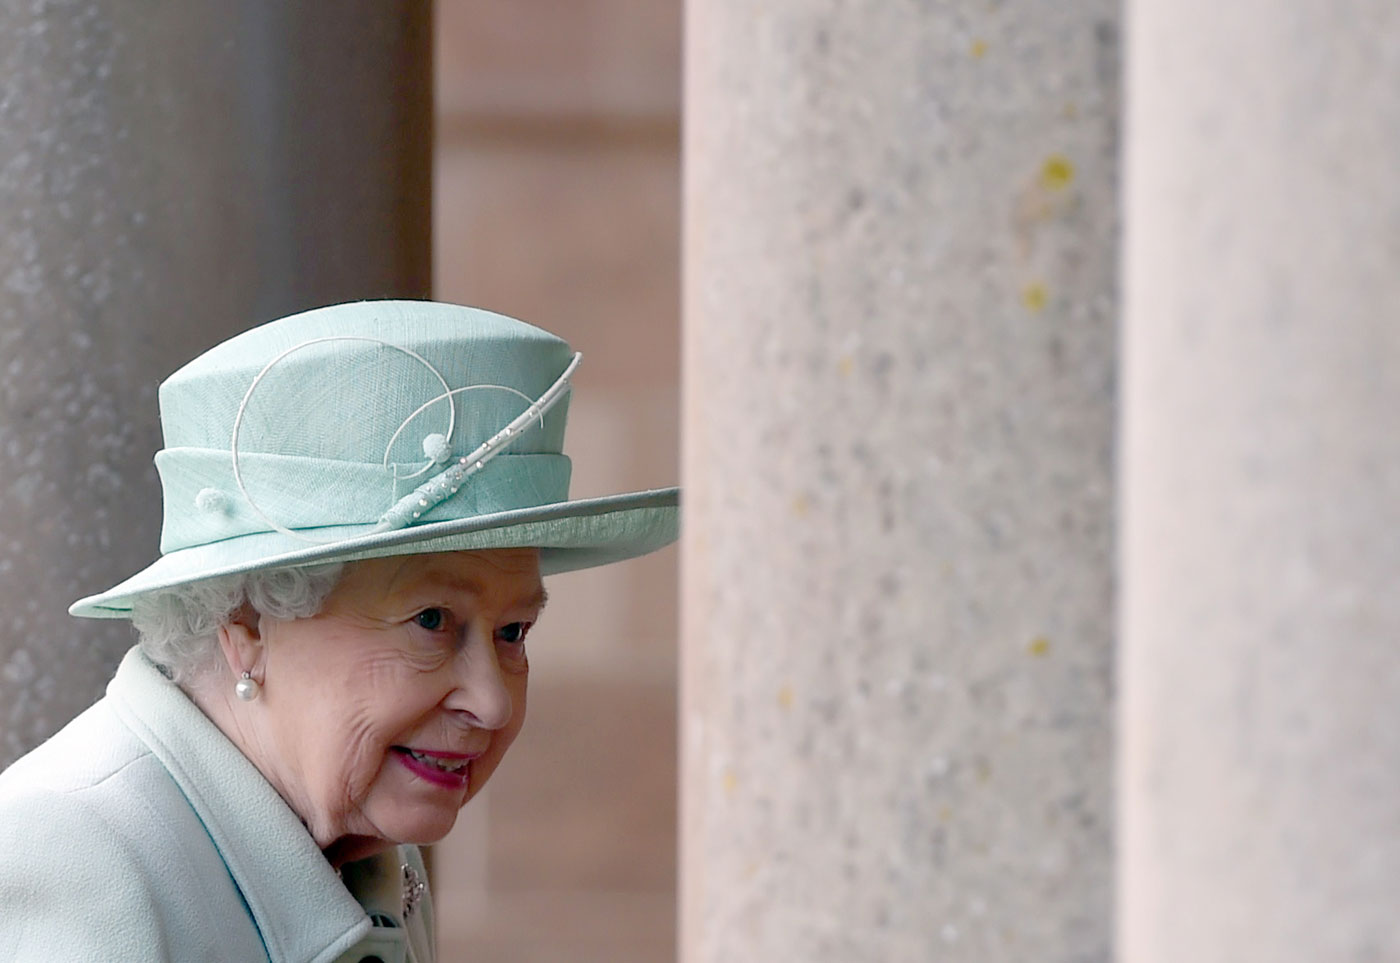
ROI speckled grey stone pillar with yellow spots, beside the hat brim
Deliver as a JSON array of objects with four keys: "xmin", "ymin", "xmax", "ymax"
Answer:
[{"xmin": 680, "ymin": 0, "xmax": 1119, "ymax": 963}]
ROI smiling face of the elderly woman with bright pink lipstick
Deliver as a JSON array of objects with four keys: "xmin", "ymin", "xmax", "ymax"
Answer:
[{"xmin": 238, "ymin": 549, "xmax": 545, "ymax": 851}]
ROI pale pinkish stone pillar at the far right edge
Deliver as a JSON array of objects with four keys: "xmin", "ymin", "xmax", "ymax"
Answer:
[{"xmin": 1120, "ymin": 0, "xmax": 1400, "ymax": 963}]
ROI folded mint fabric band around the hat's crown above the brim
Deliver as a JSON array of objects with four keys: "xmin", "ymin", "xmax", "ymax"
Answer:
[{"xmin": 155, "ymin": 448, "xmax": 571, "ymax": 554}]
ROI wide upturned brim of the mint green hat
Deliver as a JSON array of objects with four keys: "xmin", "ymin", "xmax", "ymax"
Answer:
[{"xmin": 69, "ymin": 488, "xmax": 680, "ymax": 619}]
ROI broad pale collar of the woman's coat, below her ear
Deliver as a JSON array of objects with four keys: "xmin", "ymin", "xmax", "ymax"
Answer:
[{"xmin": 106, "ymin": 648, "xmax": 370, "ymax": 963}]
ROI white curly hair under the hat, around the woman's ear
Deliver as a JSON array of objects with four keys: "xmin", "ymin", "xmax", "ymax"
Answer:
[{"xmin": 132, "ymin": 563, "xmax": 344, "ymax": 683}]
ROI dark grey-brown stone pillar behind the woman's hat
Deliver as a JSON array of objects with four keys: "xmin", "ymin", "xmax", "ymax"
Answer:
[{"xmin": 0, "ymin": 0, "xmax": 431, "ymax": 764}]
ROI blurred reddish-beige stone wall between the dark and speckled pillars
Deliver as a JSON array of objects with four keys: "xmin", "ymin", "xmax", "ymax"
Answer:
[{"xmin": 434, "ymin": 0, "xmax": 680, "ymax": 963}]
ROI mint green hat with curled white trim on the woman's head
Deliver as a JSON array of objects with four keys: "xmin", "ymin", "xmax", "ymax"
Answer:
[{"xmin": 69, "ymin": 301, "xmax": 679, "ymax": 619}]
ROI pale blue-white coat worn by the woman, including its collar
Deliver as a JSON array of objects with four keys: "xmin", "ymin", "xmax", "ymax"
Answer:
[{"xmin": 0, "ymin": 648, "xmax": 434, "ymax": 963}]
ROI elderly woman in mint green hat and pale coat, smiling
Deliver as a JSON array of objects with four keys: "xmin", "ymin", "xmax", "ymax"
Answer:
[{"xmin": 0, "ymin": 301, "xmax": 678, "ymax": 963}]
